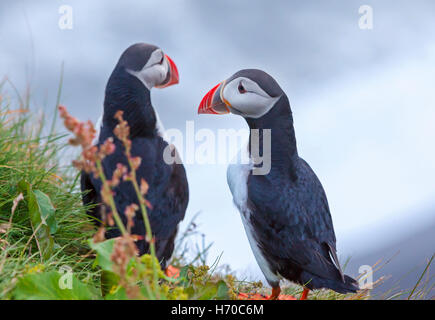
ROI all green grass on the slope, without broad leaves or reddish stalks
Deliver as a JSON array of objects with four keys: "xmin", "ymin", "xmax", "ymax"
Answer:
[{"xmin": 0, "ymin": 82, "xmax": 431, "ymax": 300}]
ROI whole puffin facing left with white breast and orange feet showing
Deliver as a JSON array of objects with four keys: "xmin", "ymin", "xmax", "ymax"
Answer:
[{"xmin": 198, "ymin": 69, "xmax": 358, "ymax": 300}]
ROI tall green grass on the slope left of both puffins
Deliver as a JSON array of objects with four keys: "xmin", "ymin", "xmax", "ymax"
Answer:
[{"xmin": 0, "ymin": 82, "xmax": 96, "ymax": 299}]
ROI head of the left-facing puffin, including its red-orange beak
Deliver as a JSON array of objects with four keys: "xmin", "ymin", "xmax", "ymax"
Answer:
[{"xmin": 198, "ymin": 69, "xmax": 284, "ymax": 119}]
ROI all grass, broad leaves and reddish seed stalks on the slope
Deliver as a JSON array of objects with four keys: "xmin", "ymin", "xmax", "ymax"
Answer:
[{"xmin": 0, "ymin": 83, "xmax": 430, "ymax": 299}]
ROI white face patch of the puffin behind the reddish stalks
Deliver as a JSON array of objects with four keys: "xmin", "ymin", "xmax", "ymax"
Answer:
[{"xmin": 127, "ymin": 49, "xmax": 169, "ymax": 90}]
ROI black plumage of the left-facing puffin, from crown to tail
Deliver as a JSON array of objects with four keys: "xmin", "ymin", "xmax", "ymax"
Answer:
[{"xmin": 245, "ymin": 71, "xmax": 357, "ymax": 293}]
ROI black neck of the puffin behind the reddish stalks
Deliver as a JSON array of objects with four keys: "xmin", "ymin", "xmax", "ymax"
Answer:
[{"xmin": 103, "ymin": 67, "xmax": 156, "ymax": 138}]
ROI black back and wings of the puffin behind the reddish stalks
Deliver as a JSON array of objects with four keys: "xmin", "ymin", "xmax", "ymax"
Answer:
[{"xmin": 90, "ymin": 137, "xmax": 189, "ymax": 265}]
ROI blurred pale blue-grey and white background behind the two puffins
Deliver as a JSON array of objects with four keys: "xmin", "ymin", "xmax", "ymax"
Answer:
[{"xmin": 0, "ymin": 0, "xmax": 435, "ymax": 290}]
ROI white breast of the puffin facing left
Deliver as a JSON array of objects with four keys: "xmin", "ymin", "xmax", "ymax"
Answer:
[{"xmin": 227, "ymin": 146, "xmax": 279, "ymax": 284}]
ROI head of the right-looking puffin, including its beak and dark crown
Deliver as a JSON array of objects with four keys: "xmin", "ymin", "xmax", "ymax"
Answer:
[{"xmin": 118, "ymin": 43, "xmax": 178, "ymax": 90}]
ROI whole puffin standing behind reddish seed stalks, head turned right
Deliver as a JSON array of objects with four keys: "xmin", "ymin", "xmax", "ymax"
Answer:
[{"xmin": 81, "ymin": 43, "xmax": 189, "ymax": 269}]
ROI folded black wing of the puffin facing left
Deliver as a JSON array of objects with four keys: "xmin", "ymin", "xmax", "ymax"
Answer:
[{"xmin": 248, "ymin": 159, "xmax": 342, "ymax": 279}]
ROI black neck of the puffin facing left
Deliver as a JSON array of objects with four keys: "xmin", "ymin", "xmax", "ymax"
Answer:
[{"xmin": 246, "ymin": 94, "xmax": 298, "ymax": 176}]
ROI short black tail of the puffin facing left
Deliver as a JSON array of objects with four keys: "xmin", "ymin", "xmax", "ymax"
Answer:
[{"xmin": 301, "ymin": 272, "xmax": 359, "ymax": 293}]
